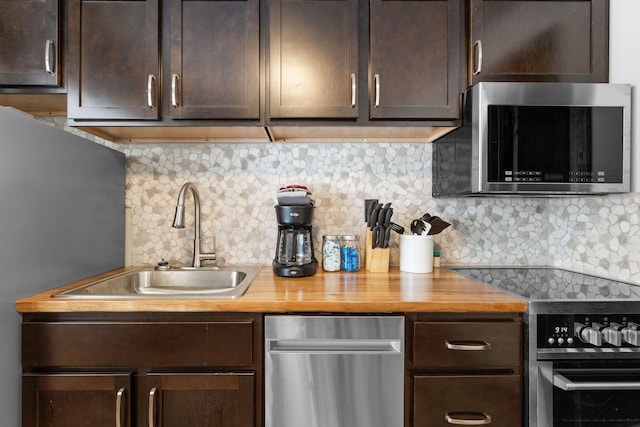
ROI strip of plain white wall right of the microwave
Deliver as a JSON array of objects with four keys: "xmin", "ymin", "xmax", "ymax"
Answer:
[{"xmin": 609, "ymin": 0, "xmax": 640, "ymax": 193}]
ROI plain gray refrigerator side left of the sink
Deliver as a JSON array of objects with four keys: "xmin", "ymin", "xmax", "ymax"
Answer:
[{"xmin": 0, "ymin": 108, "xmax": 125, "ymax": 427}]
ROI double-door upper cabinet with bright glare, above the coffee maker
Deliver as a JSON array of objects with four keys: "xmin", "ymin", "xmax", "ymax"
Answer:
[{"xmin": 269, "ymin": 0, "xmax": 462, "ymax": 124}]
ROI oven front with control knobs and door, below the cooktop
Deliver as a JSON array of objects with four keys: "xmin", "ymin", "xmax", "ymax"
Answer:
[{"xmin": 530, "ymin": 307, "xmax": 640, "ymax": 427}]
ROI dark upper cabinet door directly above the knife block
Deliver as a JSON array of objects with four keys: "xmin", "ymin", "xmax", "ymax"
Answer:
[{"xmin": 369, "ymin": 0, "xmax": 461, "ymax": 119}]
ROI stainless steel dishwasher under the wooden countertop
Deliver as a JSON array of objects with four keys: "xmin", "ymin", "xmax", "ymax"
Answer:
[{"xmin": 265, "ymin": 315, "xmax": 404, "ymax": 427}]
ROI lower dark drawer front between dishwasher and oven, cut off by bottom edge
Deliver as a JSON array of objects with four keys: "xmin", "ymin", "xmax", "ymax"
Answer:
[{"xmin": 413, "ymin": 375, "xmax": 522, "ymax": 427}]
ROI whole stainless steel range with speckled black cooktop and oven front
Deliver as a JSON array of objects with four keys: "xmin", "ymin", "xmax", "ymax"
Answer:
[{"xmin": 453, "ymin": 267, "xmax": 640, "ymax": 427}]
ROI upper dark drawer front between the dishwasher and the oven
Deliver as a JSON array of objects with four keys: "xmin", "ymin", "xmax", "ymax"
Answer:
[{"xmin": 413, "ymin": 321, "xmax": 522, "ymax": 369}]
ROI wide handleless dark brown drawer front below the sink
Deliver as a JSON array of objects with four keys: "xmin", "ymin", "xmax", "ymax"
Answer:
[{"xmin": 22, "ymin": 321, "xmax": 253, "ymax": 367}]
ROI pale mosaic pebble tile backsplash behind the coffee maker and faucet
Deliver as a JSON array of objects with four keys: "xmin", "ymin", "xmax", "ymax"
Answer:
[{"xmin": 42, "ymin": 117, "xmax": 640, "ymax": 283}]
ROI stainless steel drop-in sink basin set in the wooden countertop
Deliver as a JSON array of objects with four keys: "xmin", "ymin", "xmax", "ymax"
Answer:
[{"xmin": 53, "ymin": 266, "xmax": 261, "ymax": 298}]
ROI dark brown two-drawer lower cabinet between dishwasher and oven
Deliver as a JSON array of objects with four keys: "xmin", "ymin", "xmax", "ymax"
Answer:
[{"xmin": 405, "ymin": 313, "xmax": 523, "ymax": 427}]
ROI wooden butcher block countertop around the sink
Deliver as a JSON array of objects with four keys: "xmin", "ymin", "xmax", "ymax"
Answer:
[{"xmin": 16, "ymin": 266, "xmax": 527, "ymax": 313}]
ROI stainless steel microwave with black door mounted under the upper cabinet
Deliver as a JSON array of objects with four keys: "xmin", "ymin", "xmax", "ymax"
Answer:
[{"xmin": 432, "ymin": 82, "xmax": 631, "ymax": 197}]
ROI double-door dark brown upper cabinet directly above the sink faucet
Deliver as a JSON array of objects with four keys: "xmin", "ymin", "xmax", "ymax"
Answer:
[{"xmin": 68, "ymin": 0, "xmax": 260, "ymax": 121}]
